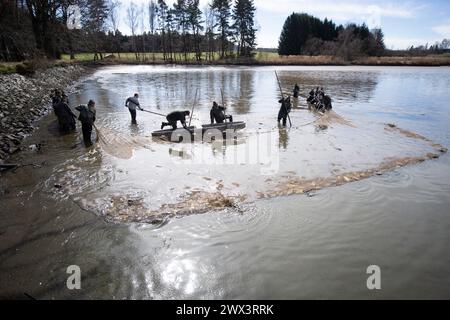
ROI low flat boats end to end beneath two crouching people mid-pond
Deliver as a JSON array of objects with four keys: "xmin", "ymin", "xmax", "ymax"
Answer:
[{"xmin": 152, "ymin": 121, "xmax": 245, "ymax": 140}]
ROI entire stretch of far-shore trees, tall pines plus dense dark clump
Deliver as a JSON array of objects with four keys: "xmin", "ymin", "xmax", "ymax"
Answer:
[{"xmin": 0, "ymin": 0, "xmax": 450, "ymax": 62}]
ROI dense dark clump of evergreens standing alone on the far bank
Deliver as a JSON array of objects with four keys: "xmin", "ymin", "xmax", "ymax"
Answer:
[{"xmin": 278, "ymin": 13, "xmax": 385, "ymax": 60}]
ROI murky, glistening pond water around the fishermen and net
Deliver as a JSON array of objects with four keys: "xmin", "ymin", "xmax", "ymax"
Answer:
[{"xmin": 0, "ymin": 66, "xmax": 450, "ymax": 299}]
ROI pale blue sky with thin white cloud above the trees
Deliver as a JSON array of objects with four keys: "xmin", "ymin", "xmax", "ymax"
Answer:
[{"xmin": 119, "ymin": 0, "xmax": 450, "ymax": 49}]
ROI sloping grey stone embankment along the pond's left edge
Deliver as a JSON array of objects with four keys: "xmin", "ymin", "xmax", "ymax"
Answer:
[{"xmin": 0, "ymin": 65, "xmax": 87, "ymax": 163}]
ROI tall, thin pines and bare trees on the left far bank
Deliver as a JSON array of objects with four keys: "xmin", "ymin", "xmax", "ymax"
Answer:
[{"xmin": 0, "ymin": 0, "xmax": 256, "ymax": 61}]
